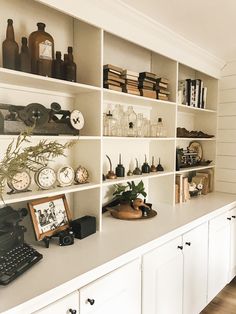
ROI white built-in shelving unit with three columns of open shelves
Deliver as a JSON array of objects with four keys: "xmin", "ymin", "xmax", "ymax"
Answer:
[{"xmin": 0, "ymin": 0, "xmax": 218, "ymax": 230}]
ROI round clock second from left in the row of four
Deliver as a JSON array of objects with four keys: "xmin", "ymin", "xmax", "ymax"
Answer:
[{"xmin": 35, "ymin": 167, "xmax": 56, "ymax": 190}]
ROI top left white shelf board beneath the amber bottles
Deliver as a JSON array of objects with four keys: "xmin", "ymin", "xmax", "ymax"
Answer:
[{"xmin": 0, "ymin": 68, "xmax": 101, "ymax": 94}]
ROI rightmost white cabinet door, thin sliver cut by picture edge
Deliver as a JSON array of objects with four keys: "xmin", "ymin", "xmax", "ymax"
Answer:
[{"xmin": 228, "ymin": 208, "xmax": 236, "ymax": 281}]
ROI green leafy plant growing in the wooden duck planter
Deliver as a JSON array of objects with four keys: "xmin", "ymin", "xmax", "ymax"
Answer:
[{"xmin": 113, "ymin": 181, "xmax": 147, "ymax": 202}]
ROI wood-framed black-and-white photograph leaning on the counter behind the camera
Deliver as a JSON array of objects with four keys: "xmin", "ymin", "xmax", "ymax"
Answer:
[{"xmin": 28, "ymin": 194, "xmax": 71, "ymax": 241}]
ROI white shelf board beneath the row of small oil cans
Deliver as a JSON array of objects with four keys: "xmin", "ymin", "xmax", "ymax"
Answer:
[{"xmin": 102, "ymin": 171, "xmax": 174, "ymax": 186}]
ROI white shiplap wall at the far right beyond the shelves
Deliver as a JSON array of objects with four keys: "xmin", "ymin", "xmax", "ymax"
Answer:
[{"xmin": 215, "ymin": 61, "xmax": 236, "ymax": 193}]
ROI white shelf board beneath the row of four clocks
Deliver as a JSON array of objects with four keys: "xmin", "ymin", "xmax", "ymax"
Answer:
[{"xmin": 0, "ymin": 182, "xmax": 100, "ymax": 204}]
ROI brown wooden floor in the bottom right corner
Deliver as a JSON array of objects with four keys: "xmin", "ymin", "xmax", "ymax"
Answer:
[{"xmin": 201, "ymin": 277, "xmax": 236, "ymax": 314}]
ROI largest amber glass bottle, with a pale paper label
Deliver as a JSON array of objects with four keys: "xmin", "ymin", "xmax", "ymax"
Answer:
[{"xmin": 29, "ymin": 23, "xmax": 54, "ymax": 76}]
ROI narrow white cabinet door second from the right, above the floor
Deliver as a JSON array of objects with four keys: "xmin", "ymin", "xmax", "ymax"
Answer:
[{"xmin": 208, "ymin": 212, "xmax": 230, "ymax": 302}]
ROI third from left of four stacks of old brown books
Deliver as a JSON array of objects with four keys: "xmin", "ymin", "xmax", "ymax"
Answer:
[{"xmin": 138, "ymin": 72, "xmax": 157, "ymax": 98}]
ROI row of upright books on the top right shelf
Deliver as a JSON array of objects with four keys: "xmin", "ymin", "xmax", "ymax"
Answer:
[{"xmin": 178, "ymin": 79, "xmax": 207, "ymax": 109}]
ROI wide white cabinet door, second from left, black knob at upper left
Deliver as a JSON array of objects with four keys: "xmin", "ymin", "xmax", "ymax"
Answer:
[{"xmin": 80, "ymin": 260, "xmax": 141, "ymax": 314}]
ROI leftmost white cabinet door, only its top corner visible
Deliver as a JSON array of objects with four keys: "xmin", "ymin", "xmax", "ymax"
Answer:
[{"xmin": 34, "ymin": 291, "xmax": 79, "ymax": 314}]
